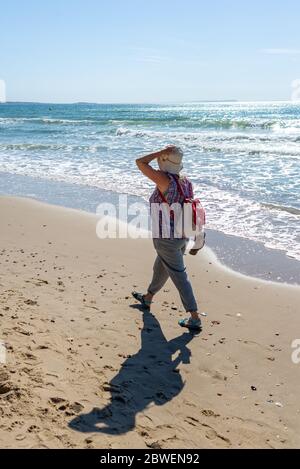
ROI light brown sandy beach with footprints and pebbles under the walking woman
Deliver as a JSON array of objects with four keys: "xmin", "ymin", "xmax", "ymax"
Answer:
[{"xmin": 0, "ymin": 197, "xmax": 300, "ymax": 448}]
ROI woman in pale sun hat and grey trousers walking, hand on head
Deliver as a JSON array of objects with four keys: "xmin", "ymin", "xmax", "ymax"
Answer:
[{"xmin": 132, "ymin": 146, "xmax": 201, "ymax": 330}]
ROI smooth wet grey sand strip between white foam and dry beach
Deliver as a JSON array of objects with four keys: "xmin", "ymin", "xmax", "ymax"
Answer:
[{"xmin": 0, "ymin": 172, "xmax": 300, "ymax": 285}]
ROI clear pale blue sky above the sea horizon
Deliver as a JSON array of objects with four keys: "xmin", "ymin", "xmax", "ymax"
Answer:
[{"xmin": 0, "ymin": 0, "xmax": 300, "ymax": 102}]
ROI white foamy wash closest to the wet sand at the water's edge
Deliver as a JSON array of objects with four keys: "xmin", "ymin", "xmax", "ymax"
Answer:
[{"xmin": 0, "ymin": 148, "xmax": 300, "ymax": 260}]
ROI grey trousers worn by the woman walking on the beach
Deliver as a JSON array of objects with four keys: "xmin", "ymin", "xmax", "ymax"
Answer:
[{"xmin": 148, "ymin": 238, "xmax": 198, "ymax": 312}]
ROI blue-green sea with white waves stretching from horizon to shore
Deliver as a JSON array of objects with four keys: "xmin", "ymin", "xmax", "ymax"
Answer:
[{"xmin": 0, "ymin": 102, "xmax": 300, "ymax": 260}]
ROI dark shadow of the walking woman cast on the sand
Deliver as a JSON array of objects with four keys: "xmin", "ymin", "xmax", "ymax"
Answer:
[{"xmin": 69, "ymin": 305, "xmax": 199, "ymax": 435}]
